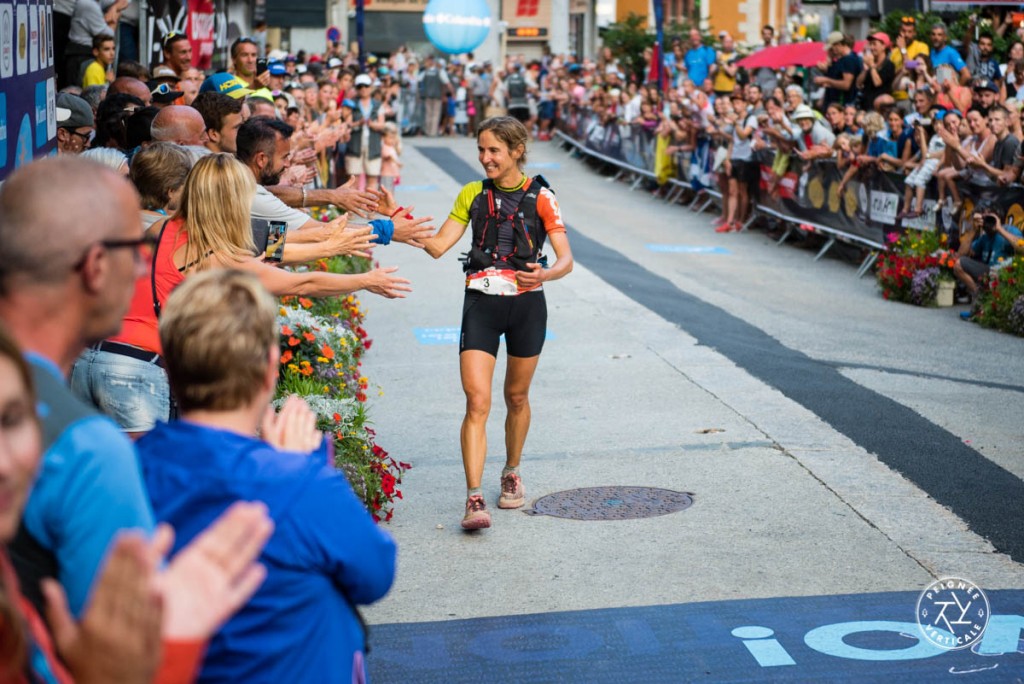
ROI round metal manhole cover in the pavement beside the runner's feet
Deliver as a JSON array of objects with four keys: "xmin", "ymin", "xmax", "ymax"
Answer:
[{"xmin": 525, "ymin": 486, "xmax": 693, "ymax": 520}]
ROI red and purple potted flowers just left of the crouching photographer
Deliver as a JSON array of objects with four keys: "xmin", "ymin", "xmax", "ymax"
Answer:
[{"xmin": 876, "ymin": 230, "xmax": 956, "ymax": 306}]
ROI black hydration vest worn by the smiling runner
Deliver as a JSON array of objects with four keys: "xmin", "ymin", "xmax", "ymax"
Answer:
[{"xmin": 463, "ymin": 175, "xmax": 551, "ymax": 273}]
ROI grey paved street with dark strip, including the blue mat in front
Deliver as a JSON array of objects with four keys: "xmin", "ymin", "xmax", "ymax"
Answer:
[{"xmin": 364, "ymin": 139, "xmax": 1024, "ymax": 682}]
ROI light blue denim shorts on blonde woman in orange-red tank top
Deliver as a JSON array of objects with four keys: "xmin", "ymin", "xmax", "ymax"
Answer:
[{"xmin": 71, "ymin": 348, "xmax": 171, "ymax": 432}]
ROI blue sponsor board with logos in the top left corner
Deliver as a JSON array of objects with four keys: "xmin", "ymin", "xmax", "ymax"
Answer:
[{"xmin": 0, "ymin": 0, "xmax": 57, "ymax": 180}]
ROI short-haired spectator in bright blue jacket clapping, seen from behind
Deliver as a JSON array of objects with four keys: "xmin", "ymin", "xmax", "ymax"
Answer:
[{"xmin": 137, "ymin": 269, "xmax": 395, "ymax": 684}]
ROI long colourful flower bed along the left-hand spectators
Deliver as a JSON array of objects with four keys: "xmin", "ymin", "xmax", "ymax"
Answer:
[{"xmin": 274, "ymin": 257, "xmax": 411, "ymax": 522}]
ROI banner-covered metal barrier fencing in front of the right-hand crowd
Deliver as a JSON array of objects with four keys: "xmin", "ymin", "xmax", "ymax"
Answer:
[{"xmin": 556, "ymin": 109, "xmax": 1024, "ymax": 276}]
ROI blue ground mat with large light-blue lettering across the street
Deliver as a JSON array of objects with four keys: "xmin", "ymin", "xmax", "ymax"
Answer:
[{"xmin": 369, "ymin": 590, "xmax": 1024, "ymax": 684}]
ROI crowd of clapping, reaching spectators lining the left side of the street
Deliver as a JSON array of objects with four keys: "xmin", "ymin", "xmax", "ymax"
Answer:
[{"xmin": 0, "ymin": 24, "xmax": 464, "ymax": 683}]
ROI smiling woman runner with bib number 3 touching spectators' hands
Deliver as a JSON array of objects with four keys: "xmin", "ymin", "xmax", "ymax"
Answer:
[{"xmin": 423, "ymin": 117, "xmax": 572, "ymax": 529}]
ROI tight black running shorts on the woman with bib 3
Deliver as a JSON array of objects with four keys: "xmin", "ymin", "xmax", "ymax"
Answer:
[{"xmin": 459, "ymin": 290, "xmax": 548, "ymax": 358}]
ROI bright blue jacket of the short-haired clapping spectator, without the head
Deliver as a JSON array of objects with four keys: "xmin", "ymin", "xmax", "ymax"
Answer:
[{"xmin": 137, "ymin": 421, "xmax": 396, "ymax": 684}]
